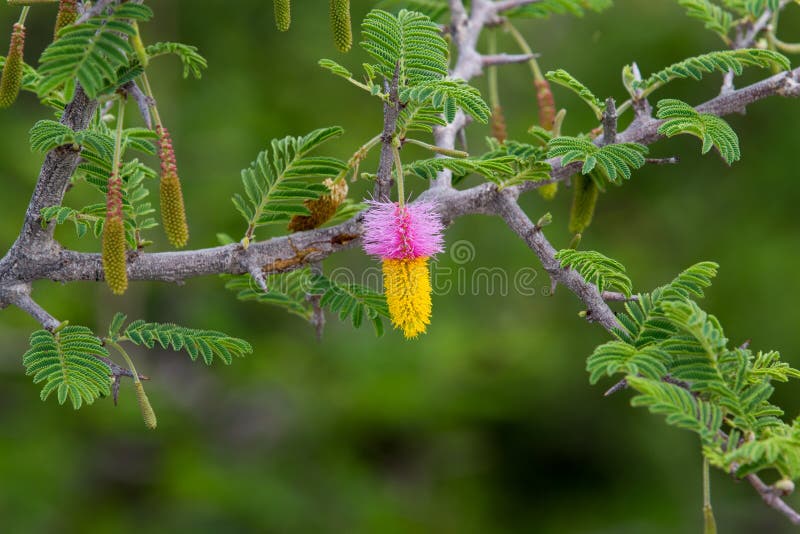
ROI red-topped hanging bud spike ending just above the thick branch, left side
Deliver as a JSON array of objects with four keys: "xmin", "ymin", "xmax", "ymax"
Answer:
[{"xmin": 156, "ymin": 126, "xmax": 189, "ymax": 248}]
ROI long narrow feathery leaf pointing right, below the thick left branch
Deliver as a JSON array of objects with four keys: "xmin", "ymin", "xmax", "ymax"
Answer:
[{"xmin": 116, "ymin": 314, "xmax": 253, "ymax": 365}]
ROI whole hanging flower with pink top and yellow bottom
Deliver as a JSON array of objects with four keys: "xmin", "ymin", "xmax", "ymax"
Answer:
[{"xmin": 364, "ymin": 201, "xmax": 444, "ymax": 338}]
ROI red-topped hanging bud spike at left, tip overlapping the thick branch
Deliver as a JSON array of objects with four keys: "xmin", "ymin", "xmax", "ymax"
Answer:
[{"xmin": 103, "ymin": 172, "xmax": 128, "ymax": 295}]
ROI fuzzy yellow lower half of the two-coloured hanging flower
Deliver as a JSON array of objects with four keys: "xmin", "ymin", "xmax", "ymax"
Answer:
[{"xmin": 383, "ymin": 256, "xmax": 432, "ymax": 339}]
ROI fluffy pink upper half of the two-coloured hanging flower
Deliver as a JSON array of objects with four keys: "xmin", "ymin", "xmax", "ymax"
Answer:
[{"xmin": 364, "ymin": 201, "xmax": 444, "ymax": 260}]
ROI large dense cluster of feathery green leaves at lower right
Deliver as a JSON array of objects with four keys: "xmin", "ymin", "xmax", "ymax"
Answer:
[{"xmin": 584, "ymin": 262, "xmax": 800, "ymax": 480}]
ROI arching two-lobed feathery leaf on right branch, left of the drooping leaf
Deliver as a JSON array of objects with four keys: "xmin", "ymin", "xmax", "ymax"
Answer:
[{"xmin": 547, "ymin": 136, "xmax": 648, "ymax": 183}]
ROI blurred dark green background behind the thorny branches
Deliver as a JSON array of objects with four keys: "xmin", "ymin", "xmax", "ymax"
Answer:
[{"xmin": 0, "ymin": 0, "xmax": 800, "ymax": 533}]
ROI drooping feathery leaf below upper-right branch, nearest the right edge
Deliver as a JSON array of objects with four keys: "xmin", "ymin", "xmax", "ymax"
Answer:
[{"xmin": 657, "ymin": 98, "xmax": 742, "ymax": 165}]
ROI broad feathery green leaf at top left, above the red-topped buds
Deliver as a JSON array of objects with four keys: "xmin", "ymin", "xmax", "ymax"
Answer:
[{"xmin": 37, "ymin": 2, "xmax": 153, "ymax": 98}]
